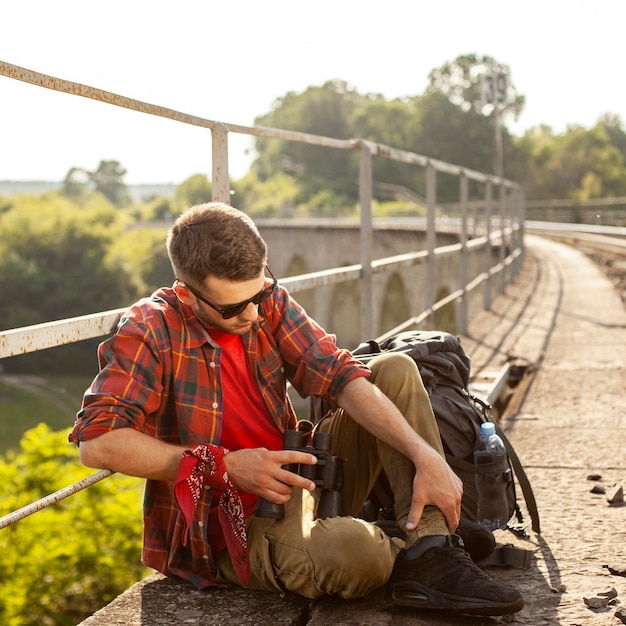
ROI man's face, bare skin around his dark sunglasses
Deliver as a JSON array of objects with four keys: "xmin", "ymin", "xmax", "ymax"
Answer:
[{"xmin": 179, "ymin": 272, "xmax": 267, "ymax": 335}]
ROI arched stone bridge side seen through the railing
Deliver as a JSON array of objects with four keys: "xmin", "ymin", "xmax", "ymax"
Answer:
[{"xmin": 256, "ymin": 220, "xmax": 486, "ymax": 348}]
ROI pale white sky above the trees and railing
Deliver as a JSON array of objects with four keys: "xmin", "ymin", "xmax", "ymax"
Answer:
[{"xmin": 0, "ymin": 0, "xmax": 626, "ymax": 184}]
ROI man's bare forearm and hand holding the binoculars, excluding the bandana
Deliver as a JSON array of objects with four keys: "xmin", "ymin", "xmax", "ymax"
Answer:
[{"xmin": 78, "ymin": 428, "xmax": 317, "ymax": 504}]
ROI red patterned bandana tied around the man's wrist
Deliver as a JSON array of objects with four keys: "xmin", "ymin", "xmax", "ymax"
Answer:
[{"xmin": 174, "ymin": 445, "xmax": 250, "ymax": 585}]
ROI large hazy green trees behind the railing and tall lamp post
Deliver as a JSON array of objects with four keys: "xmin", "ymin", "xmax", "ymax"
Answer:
[{"xmin": 249, "ymin": 54, "xmax": 626, "ymax": 206}]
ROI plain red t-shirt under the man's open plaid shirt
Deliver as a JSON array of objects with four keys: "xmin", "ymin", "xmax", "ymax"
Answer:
[{"xmin": 207, "ymin": 329, "xmax": 283, "ymax": 553}]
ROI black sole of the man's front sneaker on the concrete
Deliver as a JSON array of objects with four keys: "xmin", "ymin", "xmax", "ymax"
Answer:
[{"xmin": 389, "ymin": 582, "xmax": 524, "ymax": 615}]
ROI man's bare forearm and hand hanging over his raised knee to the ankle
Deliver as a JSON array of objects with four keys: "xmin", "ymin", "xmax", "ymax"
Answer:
[{"xmin": 337, "ymin": 378, "xmax": 463, "ymax": 532}]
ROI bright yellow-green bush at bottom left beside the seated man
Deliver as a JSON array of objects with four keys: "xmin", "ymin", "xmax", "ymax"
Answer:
[{"xmin": 0, "ymin": 424, "xmax": 148, "ymax": 626}]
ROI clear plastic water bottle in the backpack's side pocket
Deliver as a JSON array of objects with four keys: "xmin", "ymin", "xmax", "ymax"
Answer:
[{"xmin": 474, "ymin": 422, "xmax": 512, "ymax": 531}]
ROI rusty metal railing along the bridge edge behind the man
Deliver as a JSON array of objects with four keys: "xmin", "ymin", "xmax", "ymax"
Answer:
[{"xmin": 0, "ymin": 61, "xmax": 524, "ymax": 528}]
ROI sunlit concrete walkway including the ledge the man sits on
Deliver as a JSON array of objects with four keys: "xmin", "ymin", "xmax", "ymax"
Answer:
[{"xmin": 82, "ymin": 236, "xmax": 626, "ymax": 626}]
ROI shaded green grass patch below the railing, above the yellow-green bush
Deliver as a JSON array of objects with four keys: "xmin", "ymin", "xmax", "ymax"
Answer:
[{"xmin": 0, "ymin": 376, "xmax": 91, "ymax": 454}]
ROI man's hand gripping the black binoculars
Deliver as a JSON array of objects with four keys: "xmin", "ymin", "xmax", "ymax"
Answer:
[{"xmin": 224, "ymin": 448, "xmax": 317, "ymax": 504}]
